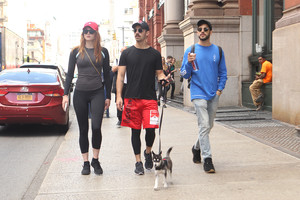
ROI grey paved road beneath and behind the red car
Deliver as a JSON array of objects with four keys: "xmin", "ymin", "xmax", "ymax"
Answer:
[{"xmin": 0, "ymin": 125, "xmax": 64, "ymax": 200}]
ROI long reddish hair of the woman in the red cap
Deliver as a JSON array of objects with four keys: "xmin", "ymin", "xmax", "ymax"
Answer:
[{"xmin": 75, "ymin": 31, "xmax": 102, "ymax": 63}]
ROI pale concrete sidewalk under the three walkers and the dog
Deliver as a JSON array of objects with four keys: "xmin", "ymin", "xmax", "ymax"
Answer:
[{"xmin": 36, "ymin": 103, "xmax": 300, "ymax": 200}]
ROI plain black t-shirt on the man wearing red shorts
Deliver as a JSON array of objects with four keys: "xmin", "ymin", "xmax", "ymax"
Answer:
[{"xmin": 119, "ymin": 46, "xmax": 162, "ymax": 100}]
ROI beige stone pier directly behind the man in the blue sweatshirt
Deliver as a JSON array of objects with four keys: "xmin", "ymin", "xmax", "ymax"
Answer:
[{"xmin": 179, "ymin": 0, "xmax": 241, "ymax": 106}]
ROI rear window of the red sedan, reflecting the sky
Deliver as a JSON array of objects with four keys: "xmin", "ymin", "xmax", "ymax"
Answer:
[{"xmin": 0, "ymin": 70, "xmax": 57, "ymax": 85}]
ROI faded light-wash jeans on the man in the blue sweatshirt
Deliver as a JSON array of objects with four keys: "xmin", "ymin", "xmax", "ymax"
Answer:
[{"xmin": 193, "ymin": 95, "xmax": 220, "ymax": 159}]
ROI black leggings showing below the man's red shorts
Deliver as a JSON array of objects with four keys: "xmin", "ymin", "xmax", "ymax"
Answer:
[{"xmin": 131, "ymin": 128, "xmax": 155, "ymax": 155}]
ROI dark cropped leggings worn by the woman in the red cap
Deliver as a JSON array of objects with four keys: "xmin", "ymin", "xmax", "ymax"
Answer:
[{"xmin": 73, "ymin": 87, "xmax": 105, "ymax": 153}]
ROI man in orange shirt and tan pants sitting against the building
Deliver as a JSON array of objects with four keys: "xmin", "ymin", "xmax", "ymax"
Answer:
[{"xmin": 249, "ymin": 55, "xmax": 272, "ymax": 111}]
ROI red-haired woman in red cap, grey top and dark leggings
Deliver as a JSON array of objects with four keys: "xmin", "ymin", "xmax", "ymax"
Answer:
[{"xmin": 62, "ymin": 22, "xmax": 111, "ymax": 175}]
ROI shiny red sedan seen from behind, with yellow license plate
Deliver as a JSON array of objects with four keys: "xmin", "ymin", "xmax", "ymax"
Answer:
[{"xmin": 0, "ymin": 68, "xmax": 69, "ymax": 131}]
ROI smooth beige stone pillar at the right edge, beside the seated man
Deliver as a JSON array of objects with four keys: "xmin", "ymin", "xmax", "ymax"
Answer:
[{"xmin": 272, "ymin": 0, "xmax": 300, "ymax": 125}]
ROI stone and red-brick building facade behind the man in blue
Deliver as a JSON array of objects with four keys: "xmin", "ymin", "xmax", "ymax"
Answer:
[{"xmin": 139, "ymin": 0, "xmax": 300, "ymax": 125}]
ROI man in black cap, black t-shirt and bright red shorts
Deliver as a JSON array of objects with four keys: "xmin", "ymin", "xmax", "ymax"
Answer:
[{"xmin": 116, "ymin": 21, "xmax": 169, "ymax": 175}]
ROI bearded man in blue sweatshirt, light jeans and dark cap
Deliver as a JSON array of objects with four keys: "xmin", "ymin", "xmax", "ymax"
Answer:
[{"xmin": 180, "ymin": 20, "xmax": 227, "ymax": 173}]
